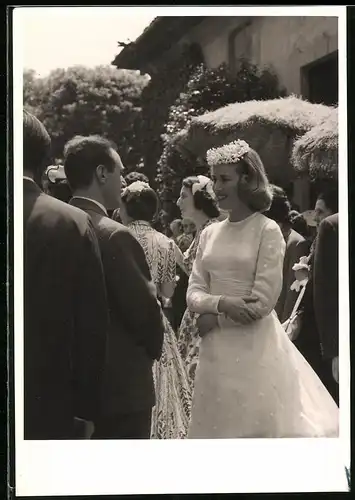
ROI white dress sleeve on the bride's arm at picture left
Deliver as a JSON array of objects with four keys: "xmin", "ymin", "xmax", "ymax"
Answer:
[{"xmin": 186, "ymin": 231, "xmax": 221, "ymax": 314}]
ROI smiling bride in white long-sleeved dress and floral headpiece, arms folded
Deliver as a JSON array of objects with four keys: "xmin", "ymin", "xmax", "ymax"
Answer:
[{"xmin": 187, "ymin": 141, "xmax": 339, "ymax": 439}]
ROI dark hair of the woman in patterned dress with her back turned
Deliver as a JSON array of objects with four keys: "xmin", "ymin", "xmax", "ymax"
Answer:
[{"xmin": 122, "ymin": 187, "xmax": 159, "ymax": 222}]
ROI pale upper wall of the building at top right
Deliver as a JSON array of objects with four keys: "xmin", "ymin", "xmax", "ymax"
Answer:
[{"xmin": 179, "ymin": 16, "xmax": 338, "ymax": 95}]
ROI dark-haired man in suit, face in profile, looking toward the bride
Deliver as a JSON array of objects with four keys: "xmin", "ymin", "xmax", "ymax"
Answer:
[{"xmin": 64, "ymin": 136, "xmax": 164, "ymax": 439}]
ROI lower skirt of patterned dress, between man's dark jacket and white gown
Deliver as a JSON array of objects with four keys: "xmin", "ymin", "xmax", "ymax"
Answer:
[{"xmin": 151, "ymin": 317, "xmax": 192, "ymax": 439}]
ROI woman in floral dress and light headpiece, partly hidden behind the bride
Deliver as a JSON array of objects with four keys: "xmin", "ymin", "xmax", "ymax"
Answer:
[{"xmin": 177, "ymin": 175, "xmax": 220, "ymax": 391}]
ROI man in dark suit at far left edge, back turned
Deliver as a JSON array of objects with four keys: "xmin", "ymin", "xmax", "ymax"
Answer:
[{"xmin": 23, "ymin": 112, "xmax": 108, "ymax": 439}]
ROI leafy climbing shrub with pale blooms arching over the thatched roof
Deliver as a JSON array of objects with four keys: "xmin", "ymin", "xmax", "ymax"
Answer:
[{"xmin": 157, "ymin": 61, "xmax": 286, "ymax": 218}]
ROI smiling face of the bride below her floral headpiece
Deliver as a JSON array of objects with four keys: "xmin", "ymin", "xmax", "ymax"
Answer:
[{"xmin": 211, "ymin": 164, "xmax": 241, "ymax": 211}]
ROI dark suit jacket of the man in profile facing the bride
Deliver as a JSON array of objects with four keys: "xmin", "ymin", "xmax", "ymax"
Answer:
[{"xmin": 70, "ymin": 197, "xmax": 164, "ymax": 417}]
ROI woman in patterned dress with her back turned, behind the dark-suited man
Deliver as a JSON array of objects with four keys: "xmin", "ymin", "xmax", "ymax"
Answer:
[{"xmin": 120, "ymin": 181, "xmax": 191, "ymax": 439}]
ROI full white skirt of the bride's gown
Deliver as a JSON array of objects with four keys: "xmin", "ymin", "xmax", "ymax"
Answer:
[{"xmin": 188, "ymin": 311, "xmax": 339, "ymax": 439}]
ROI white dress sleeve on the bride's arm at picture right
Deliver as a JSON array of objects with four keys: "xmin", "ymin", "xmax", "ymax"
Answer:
[{"xmin": 249, "ymin": 221, "xmax": 286, "ymax": 317}]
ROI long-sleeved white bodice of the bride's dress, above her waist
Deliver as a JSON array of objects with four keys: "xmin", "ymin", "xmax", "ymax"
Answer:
[{"xmin": 187, "ymin": 213, "xmax": 285, "ymax": 314}]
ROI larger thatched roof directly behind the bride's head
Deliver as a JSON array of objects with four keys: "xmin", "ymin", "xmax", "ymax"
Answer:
[{"xmin": 177, "ymin": 96, "xmax": 332, "ymax": 183}]
